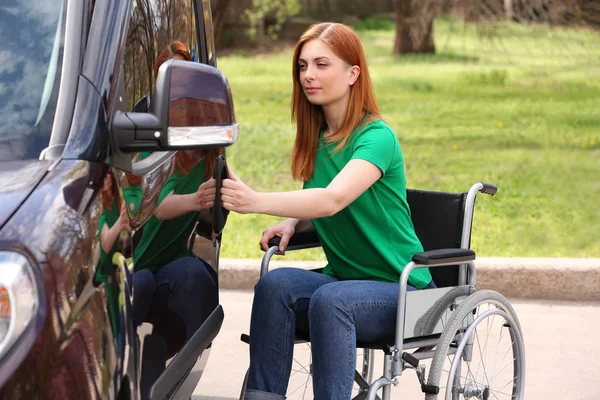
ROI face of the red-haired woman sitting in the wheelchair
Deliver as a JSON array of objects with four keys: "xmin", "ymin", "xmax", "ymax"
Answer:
[{"xmin": 298, "ymin": 39, "xmax": 360, "ymax": 106}]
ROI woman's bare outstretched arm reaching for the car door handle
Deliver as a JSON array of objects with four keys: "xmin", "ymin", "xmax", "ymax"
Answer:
[{"xmin": 221, "ymin": 159, "xmax": 382, "ymax": 219}]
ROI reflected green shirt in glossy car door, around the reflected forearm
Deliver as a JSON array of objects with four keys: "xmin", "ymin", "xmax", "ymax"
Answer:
[{"xmin": 133, "ymin": 161, "xmax": 204, "ymax": 272}]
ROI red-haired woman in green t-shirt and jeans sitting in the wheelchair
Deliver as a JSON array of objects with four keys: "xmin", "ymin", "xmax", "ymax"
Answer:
[{"xmin": 222, "ymin": 23, "xmax": 434, "ymax": 400}]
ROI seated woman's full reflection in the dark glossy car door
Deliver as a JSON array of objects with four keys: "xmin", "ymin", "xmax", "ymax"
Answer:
[{"xmin": 134, "ymin": 42, "xmax": 222, "ymax": 394}]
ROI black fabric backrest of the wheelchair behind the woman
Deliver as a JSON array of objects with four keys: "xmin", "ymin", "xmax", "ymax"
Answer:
[{"xmin": 406, "ymin": 189, "xmax": 467, "ymax": 287}]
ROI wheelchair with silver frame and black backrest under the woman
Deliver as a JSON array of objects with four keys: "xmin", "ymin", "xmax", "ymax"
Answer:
[{"xmin": 240, "ymin": 182, "xmax": 525, "ymax": 400}]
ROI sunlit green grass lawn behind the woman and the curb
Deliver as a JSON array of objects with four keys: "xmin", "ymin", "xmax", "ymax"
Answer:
[{"xmin": 219, "ymin": 18, "xmax": 600, "ymax": 259}]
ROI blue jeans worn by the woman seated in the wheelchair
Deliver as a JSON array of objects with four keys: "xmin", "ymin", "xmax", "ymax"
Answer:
[{"xmin": 245, "ymin": 268, "xmax": 435, "ymax": 400}]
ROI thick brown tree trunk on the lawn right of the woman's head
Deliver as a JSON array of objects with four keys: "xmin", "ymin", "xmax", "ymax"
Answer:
[{"xmin": 393, "ymin": 0, "xmax": 435, "ymax": 54}]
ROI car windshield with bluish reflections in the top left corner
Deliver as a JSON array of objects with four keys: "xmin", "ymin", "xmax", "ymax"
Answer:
[{"xmin": 0, "ymin": 0, "xmax": 66, "ymax": 161}]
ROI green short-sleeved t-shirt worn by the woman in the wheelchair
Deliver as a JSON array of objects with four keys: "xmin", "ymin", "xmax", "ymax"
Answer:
[{"xmin": 304, "ymin": 120, "xmax": 431, "ymax": 289}]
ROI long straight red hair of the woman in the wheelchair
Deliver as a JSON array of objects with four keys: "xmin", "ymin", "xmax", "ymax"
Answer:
[{"xmin": 292, "ymin": 22, "xmax": 380, "ymax": 181}]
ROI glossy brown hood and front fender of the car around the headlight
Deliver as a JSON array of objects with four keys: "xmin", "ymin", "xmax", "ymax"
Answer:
[{"xmin": 0, "ymin": 160, "xmax": 120, "ymax": 399}]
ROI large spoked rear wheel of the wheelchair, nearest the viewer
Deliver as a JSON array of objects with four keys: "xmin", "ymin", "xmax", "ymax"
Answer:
[{"xmin": 426, "ymin": 290, "xmax": 525, "ymax": 400}]
